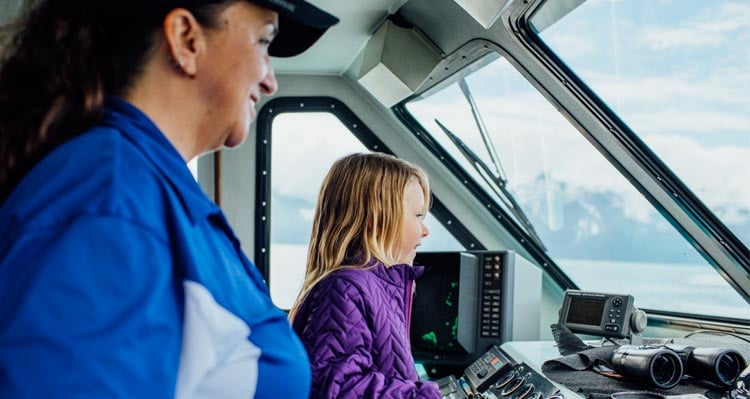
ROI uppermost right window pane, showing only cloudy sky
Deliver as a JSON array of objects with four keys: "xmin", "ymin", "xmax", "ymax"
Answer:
[{"xmin": 531, "ymin": 0, "xmax": 750, "ymax": 253}]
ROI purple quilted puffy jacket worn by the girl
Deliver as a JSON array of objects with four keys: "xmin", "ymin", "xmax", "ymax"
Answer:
[{"xmin": 293, "ymin": 261, "xmax": 441, "ymax": 399}]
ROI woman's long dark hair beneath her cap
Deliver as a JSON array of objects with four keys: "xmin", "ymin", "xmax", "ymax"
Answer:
[{"xmin": 0, "ymin": 0, "xmax": 237, "ymax": 200}]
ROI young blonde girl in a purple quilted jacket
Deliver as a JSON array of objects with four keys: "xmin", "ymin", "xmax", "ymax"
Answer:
[{"xmin": 289, "ymin": 153, "xmax": 441, "ymax": 399}]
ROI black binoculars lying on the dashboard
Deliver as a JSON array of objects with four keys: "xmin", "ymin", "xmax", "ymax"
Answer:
[{"xmin": 610, "ymin": 344, "xmax": 745, "ymax": 389}]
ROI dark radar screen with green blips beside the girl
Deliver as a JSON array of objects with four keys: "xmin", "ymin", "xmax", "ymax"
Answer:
[{"xmin": 410, "ymin": 266, "xmax": 467, "ymax": 354}]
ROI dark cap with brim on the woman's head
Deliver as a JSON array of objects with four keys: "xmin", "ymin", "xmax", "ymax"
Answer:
[{"xmin": 250, "ymin": 0, "xmax": 339, "ymax": 57}]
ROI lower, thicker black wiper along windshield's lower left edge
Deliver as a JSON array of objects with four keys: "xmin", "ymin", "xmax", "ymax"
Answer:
[{"xmin": 435, "ymin": 119, "xmax": 547, "ymax": 251}]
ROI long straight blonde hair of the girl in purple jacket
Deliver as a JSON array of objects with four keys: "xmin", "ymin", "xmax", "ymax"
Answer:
[{"xmin": 289, "ymin": 153, "xmax": 430, "ymax": 321}]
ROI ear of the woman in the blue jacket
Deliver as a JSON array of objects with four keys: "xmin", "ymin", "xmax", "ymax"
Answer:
[{"xmin": 163, "ymin": 8, "xmax": 205, "ymax": 78}]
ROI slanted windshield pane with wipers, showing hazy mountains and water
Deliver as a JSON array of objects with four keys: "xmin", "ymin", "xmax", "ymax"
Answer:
[{"xmin": 406, "ymin": 51, "xmax": 750, "ymax": 319}]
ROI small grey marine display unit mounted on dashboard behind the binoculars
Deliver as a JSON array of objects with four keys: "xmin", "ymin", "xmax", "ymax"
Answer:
[{"xmin": 559, "ymin": 290, "xmax": 647, "ymax": 338}]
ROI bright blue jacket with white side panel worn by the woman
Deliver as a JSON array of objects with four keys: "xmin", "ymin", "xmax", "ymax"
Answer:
[{"xmin": 0, "ymin": 99, "xmax": 310, "ymax": 398}]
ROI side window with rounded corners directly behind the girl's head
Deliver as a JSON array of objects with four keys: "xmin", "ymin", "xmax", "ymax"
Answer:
[{"xmin": 269, "ymin": 112, "xmax": 465, "ymax": 309}]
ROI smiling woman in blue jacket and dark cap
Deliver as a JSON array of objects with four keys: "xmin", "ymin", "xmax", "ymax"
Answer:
[{"xmin": 0, "ymin": 0, "xmax": 337, "ymax": 398}]
